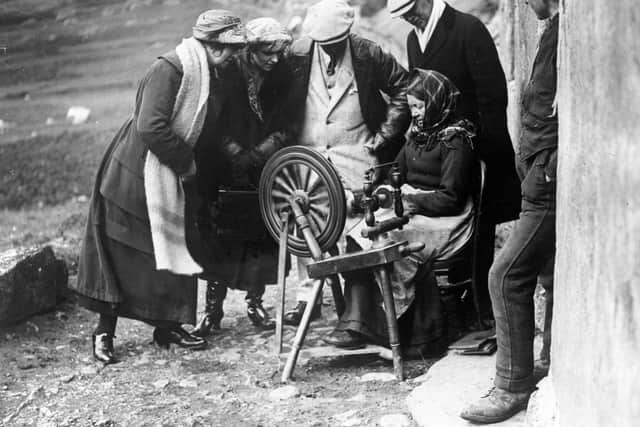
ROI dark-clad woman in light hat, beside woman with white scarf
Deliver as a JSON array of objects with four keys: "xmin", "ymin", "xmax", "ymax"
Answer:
[{"xmin": 194, "ymin": 18, "xmax": 292, "ymax": 336}]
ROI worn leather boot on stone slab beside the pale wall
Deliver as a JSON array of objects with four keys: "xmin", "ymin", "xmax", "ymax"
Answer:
[{"xmin": 460, "ymin": 387, "xmax": 533, "ymax": 424}]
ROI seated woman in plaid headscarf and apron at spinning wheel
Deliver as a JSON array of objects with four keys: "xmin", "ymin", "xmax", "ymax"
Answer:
[{"xmin": 325, "ymin": 69, "xmax": 475, "ymax": 354}]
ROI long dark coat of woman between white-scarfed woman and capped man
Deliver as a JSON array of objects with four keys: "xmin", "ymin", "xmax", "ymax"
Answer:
[{"xmin": 195, "ymin": 50, "xmax": 292, "ymax": 290}]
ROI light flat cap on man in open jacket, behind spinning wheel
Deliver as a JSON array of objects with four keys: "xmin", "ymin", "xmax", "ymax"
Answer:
[{"xmin": 303, "ymin": 0, "xmax": 355, "ymax": 45}]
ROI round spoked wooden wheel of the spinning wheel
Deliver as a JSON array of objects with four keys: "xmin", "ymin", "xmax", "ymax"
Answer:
[{"xmin": 259, "ymin": 146, "xmax": 347, "ymax": 257}]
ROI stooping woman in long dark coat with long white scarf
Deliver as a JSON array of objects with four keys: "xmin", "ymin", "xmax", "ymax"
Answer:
[{"xmin": 72, "ymin": 10, "xmax": 246, "ymax": 364}]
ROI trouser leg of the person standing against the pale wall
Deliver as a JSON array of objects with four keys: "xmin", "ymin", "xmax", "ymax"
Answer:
[{"xmin": 489, "ymin": 200, "xmax": 555, "ymax": 393}]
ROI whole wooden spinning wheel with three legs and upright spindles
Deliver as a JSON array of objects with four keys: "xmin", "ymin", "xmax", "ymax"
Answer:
[{"xmin": 259, "ymin": 146, "xmax": 424, "ymax": 381}]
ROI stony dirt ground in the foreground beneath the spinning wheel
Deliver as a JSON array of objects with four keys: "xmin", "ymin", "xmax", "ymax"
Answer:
[{"xmin": 0, "ymin": 280, "xmax": 433, "ymax": 426}]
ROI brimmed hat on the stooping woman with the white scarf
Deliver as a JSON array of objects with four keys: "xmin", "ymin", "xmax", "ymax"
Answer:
[{"xmin": 193, "ymin": 9, "xmax": 247, "ymax": 45}]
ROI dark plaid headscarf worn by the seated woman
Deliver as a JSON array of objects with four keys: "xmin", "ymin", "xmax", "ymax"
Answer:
[{"xmin": 407, "ymin": 68, "xmax": 475, "ymax": 150}]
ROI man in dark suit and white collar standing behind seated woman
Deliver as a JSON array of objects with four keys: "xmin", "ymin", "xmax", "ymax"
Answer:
[{"xmin": 387, "ymin": 0, "xmax": 520, "ymax": 320}]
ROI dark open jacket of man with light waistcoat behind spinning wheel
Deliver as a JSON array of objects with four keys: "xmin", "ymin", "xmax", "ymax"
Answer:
[{"xmin": 286, "ymin": 34, "xmax": 411, "ymax": 162}]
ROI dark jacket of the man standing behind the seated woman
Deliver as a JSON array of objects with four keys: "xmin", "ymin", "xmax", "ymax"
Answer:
[{"xmin": 407, "ymin": 5, "xmax": 520, "ymax": 223}]
